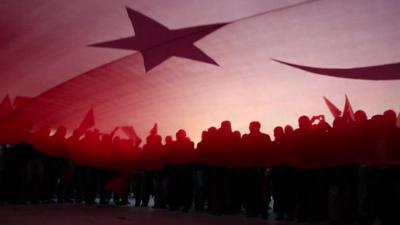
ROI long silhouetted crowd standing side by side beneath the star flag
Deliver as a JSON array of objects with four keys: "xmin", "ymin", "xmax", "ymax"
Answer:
[{"xmin": 0, "ymin": 110, "xmax": 400, "ymax": 224}]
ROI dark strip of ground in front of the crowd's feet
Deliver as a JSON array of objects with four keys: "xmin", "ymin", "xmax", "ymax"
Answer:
[{"xmin": 0, "ymin": 204, "xmax": 314, "ymax": 225}]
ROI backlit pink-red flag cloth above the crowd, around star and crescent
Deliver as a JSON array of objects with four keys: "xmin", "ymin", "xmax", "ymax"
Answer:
[{"xmin": 0, "ymin": 0, "xmax": 400, "ymax": 141}]
